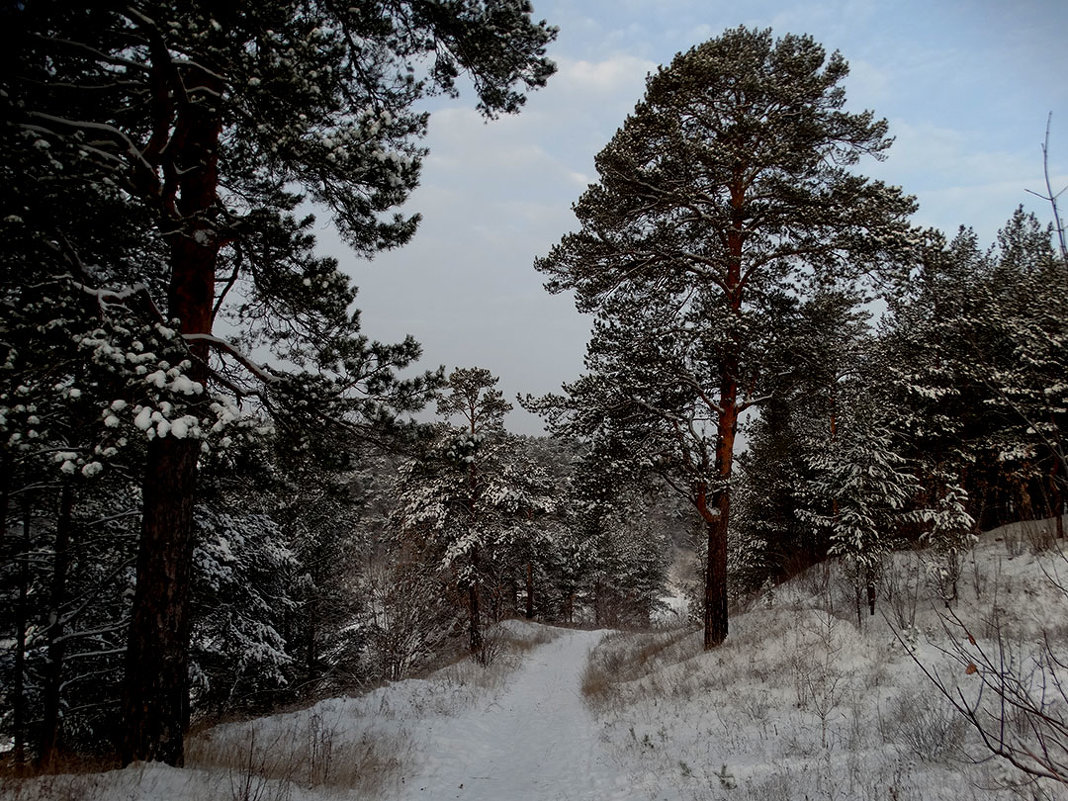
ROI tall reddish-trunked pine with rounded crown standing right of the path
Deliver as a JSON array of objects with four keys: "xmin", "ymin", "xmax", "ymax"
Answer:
[{"xmin": 536, "ymin": 28, "xmax": 914, "ymax": 647}]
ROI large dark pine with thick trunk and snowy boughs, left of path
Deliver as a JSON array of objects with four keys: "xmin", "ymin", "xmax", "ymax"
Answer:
[{"xmin": 6, "ymin": 0, "xmax": 555, "ymax": 764}]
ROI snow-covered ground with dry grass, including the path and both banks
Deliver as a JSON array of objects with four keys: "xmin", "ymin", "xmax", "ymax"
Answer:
[{"xmin": 8, "ymin": 525, "xmax": 1068, "ymax": 801}]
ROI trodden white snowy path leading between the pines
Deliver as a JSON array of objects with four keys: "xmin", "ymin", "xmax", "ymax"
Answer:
[{"xmin": 401, "ymin": 631, "xmax": 633, "ymax": 801}]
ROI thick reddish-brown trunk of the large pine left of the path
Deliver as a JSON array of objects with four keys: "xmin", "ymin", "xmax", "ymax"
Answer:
[{"xmin": 120, "ymin": 70, "xmax": 223, "ymax": 767}]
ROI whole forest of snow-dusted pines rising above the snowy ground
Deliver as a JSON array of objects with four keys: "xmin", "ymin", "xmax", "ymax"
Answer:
[{"xmin": 0, "ymin": 0, "xmax": 1068, "ymax": 798}]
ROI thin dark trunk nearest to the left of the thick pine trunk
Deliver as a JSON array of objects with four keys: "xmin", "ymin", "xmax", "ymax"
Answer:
[{"xmin": 37, "ymin": 482, "xmax": 74, "ymax": 767}]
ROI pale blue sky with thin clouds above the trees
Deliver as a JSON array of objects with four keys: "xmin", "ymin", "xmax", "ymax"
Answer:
[{"xmin": 317, "ymin": 0, "xmax": 1068, "ymax": 434}]
